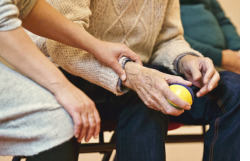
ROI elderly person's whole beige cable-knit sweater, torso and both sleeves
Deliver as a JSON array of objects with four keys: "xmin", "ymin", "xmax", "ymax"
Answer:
[{"xmin": 29, "ymin": 0, "xmax": 201, "ymax": 94}]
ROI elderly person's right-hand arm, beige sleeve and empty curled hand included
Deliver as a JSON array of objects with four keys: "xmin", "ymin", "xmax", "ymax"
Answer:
[{"xmin": 150, "ymin": 0, "xmax": 219, "ymax": 97}]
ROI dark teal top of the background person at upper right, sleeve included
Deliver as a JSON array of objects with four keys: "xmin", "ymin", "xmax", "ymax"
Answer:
[{"xmin": 180, "ymin": 0, "xmax": 240, "ymax": 66}]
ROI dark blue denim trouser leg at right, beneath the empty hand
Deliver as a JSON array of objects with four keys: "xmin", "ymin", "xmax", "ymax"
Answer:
[{"xmin": 170, "ymin": 72, "xmax": 240, "ymax": 161}]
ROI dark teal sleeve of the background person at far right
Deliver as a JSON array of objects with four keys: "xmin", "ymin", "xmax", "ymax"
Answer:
[{"xmin": 211, "ymin": 0, "xmax": 240, "ymax": 50}]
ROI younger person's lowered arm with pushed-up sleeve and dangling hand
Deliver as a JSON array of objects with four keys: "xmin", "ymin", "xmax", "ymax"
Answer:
[{"xmin": 0, "ymin": 0, "xmax": 100, "ymax": 141}]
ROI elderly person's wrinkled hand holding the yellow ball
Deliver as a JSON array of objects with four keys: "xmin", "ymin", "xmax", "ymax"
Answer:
[{"xmin": 123, "ymin": 62, "xmax": 191, "ymax": 116}]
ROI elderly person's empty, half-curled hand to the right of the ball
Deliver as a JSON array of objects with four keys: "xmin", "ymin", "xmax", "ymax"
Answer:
[{"xmin": 178, "ymin": 55, "xmax": 220, "ymax": 97}]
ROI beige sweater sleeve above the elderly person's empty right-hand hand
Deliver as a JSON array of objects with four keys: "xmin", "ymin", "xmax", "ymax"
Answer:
[{"xmin": 151, "ymin": 0, "xmax": 202, "ymax": 74}]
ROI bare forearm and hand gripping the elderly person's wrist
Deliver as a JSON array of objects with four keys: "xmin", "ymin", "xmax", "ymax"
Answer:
[{"xmin": 26, "ymin": 0, "xmax": 140, "ymax": 88}]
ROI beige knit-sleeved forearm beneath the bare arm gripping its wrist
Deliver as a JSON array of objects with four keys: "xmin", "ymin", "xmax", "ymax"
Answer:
[{"xmin": 46, "ymin": 39, "xmax": 122, "ymax": 95}]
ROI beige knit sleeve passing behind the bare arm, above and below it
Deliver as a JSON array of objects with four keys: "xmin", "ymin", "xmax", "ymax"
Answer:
[{"xmin": 29, "ymin": 0, "xmax": 122, "ymax": 95}]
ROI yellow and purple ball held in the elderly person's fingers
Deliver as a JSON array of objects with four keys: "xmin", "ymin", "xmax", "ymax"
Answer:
[{"xmin": 168, "ymin": 84, "xmax": 194, "ymax": 110}]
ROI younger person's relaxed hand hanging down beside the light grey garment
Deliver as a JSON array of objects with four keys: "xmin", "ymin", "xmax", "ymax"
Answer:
[{"xmin": 53, "ymin": 83, "xmax": 101, "ymax": 142}]
